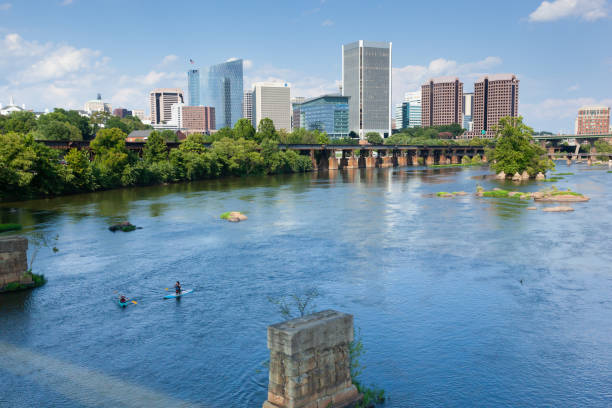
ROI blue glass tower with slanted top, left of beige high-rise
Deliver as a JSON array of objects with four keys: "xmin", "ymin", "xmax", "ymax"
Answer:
[{"xmin": 208, "ymin": 59, "xmax": 244, "ymax": 129}]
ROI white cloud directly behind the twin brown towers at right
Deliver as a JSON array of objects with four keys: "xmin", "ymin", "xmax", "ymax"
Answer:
[{"xmin": 393, "ymin": 57, "xmax": 502, "ymax": 104}]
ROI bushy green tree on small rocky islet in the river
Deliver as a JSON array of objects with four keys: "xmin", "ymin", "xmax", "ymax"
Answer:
[{"xmin": 490, "ymin": 116, "xmax": 555, "ymax": 177}]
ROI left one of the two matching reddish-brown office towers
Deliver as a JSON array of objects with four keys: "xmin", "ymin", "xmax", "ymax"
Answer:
[{"xmin": 421, "ymin": 77, "xmax": 463, "ymax": 127}]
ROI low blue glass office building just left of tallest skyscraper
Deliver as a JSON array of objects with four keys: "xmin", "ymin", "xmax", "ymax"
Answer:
[{"xmin": 293, "ymin": 95, "xmax": 349, "ymax": 139}]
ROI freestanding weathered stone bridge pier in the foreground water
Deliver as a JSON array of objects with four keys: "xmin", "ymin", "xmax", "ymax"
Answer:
[{"xmin": 263, "ymin": 310, "xmax": 362, "ymax": 408}]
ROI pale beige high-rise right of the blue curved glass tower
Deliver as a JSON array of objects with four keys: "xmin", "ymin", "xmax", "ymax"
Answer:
[{"xmin": 253, "ymin": 82, "xmax": 291, "ymax": 132}]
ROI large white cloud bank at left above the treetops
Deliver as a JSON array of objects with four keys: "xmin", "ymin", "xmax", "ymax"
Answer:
[{"xmin": 0, "ymin": 33, "xmax": 186, "ymax": 110}]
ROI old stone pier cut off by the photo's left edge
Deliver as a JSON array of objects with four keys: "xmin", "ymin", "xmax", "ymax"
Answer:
[{"xmin": 0, "ymin": 236, "xmax": 32, "ymax": 289}]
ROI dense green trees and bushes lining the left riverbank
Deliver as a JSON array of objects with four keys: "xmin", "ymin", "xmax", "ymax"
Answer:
[{"xmin": 0, "ymin": 119, "xmax": 316, "ymax": 200}]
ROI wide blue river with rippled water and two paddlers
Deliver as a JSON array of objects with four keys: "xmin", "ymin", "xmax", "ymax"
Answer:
[{"xmin": 0, "ymin": 164, "xmax": 612, "ymax": 408}]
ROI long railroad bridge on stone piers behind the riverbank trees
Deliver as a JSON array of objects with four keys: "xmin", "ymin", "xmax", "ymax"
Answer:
[{"xmin": 40, "ymin": 140, "xmax": 487, "ymax": 170}]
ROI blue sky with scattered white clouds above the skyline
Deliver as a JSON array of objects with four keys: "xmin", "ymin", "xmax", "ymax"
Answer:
[{"xmin": 0, "ymin": 0, "xmax": 612, "ymax": 132}]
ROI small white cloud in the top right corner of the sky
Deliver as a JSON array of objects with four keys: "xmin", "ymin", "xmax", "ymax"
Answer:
[{"xmin": 529, "ymin": 0, "xmax": 608, "ymax": 22}]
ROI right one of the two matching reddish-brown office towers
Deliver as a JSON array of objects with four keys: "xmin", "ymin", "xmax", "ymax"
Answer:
[{"xmin": 472, "ymin": 74, "xmax": 519, "ymax": 137}]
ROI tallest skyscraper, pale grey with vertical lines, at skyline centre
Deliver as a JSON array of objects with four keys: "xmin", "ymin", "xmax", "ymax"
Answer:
[{"xmin": 342, "ymin": 40, "xmax": 391, "ymax": 139}]
